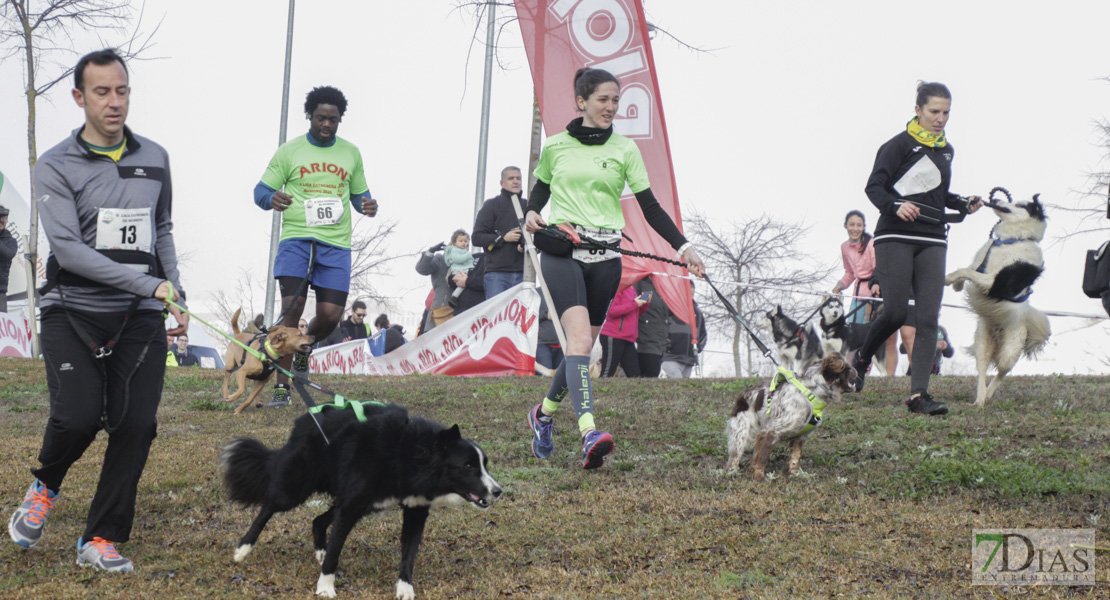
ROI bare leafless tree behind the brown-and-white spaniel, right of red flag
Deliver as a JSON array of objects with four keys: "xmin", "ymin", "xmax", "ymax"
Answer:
[{"xmin": 686, "ymin": 213, "xmax": 834, "ymax": 377}]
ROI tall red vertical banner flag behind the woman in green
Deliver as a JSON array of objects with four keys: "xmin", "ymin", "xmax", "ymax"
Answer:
[{"xmin": 515, "ymin": 0, "xmax": 697, "ymax": 332}]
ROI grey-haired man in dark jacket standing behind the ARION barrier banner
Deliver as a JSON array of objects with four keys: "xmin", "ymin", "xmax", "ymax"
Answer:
[{"xmin": 474, "ymin": 166, "xmax": 527, "ymax": 299}]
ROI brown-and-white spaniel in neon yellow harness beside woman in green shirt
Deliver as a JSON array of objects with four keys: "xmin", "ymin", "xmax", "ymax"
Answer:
[{"xmin": 725, "ymin": 353, "xmax": 856, "ymax": 480}]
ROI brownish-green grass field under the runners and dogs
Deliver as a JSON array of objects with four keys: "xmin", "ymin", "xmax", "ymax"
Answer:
[{"xmin": 0, "ymin": 358, "xmax": 1110, "ymax": 600}]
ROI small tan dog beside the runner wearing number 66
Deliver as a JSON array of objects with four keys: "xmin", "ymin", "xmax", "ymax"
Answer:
[{"xmin": 223, "ymin": 308, "xmax": 313, "ymax": 415}]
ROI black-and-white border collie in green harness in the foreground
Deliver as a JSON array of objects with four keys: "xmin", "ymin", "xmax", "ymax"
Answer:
[{"xmin": 220, "ymin": 404, "xmax": 501, "ymax": 600}]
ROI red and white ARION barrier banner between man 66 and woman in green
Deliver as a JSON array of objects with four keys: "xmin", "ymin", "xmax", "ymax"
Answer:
[{"xmin": 309, "ymin": 283, "xmax": 539, "ymax": 376}]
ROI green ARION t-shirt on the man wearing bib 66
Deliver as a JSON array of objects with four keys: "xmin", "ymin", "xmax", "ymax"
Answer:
[{"xmin": 262, "ymin": 135, "xmax": 370, "ymax": 248}]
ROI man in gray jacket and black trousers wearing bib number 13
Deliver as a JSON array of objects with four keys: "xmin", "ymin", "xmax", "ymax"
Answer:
[{"xmin": 8, "ymin": 50, "xmax": 189, "ymax": 572}]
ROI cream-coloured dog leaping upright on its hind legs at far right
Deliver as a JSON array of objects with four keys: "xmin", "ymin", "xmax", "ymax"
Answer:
[{"xmin": 945, "ymin": 194, "xmax": 1051, "ymax": 406}]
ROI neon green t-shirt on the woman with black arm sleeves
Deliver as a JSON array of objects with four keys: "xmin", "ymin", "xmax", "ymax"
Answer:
[{"xmin": 533, "ymin": 131, "xmax": 652, "ymax": 230}]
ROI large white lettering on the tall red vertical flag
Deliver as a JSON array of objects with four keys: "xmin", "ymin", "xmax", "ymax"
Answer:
[{"xmin": 551, "ymin": 0, "xmax": 655, "ymax": 139}]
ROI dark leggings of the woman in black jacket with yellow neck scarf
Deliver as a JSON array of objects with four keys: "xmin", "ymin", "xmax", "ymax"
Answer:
[{"xmin": 859, "ymin": 242, "xmax": 948, "ymax": 396}]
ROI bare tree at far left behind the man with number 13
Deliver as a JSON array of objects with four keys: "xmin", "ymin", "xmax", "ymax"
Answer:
[{"xmin": 0, "ymin": 0, "xmax": 158, "ymax": 354}]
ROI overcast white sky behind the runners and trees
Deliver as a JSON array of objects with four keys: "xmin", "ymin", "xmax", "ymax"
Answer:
[{"xmin": 0, "ymin": 0, "xmax": 1110, "ymax": 375}]
